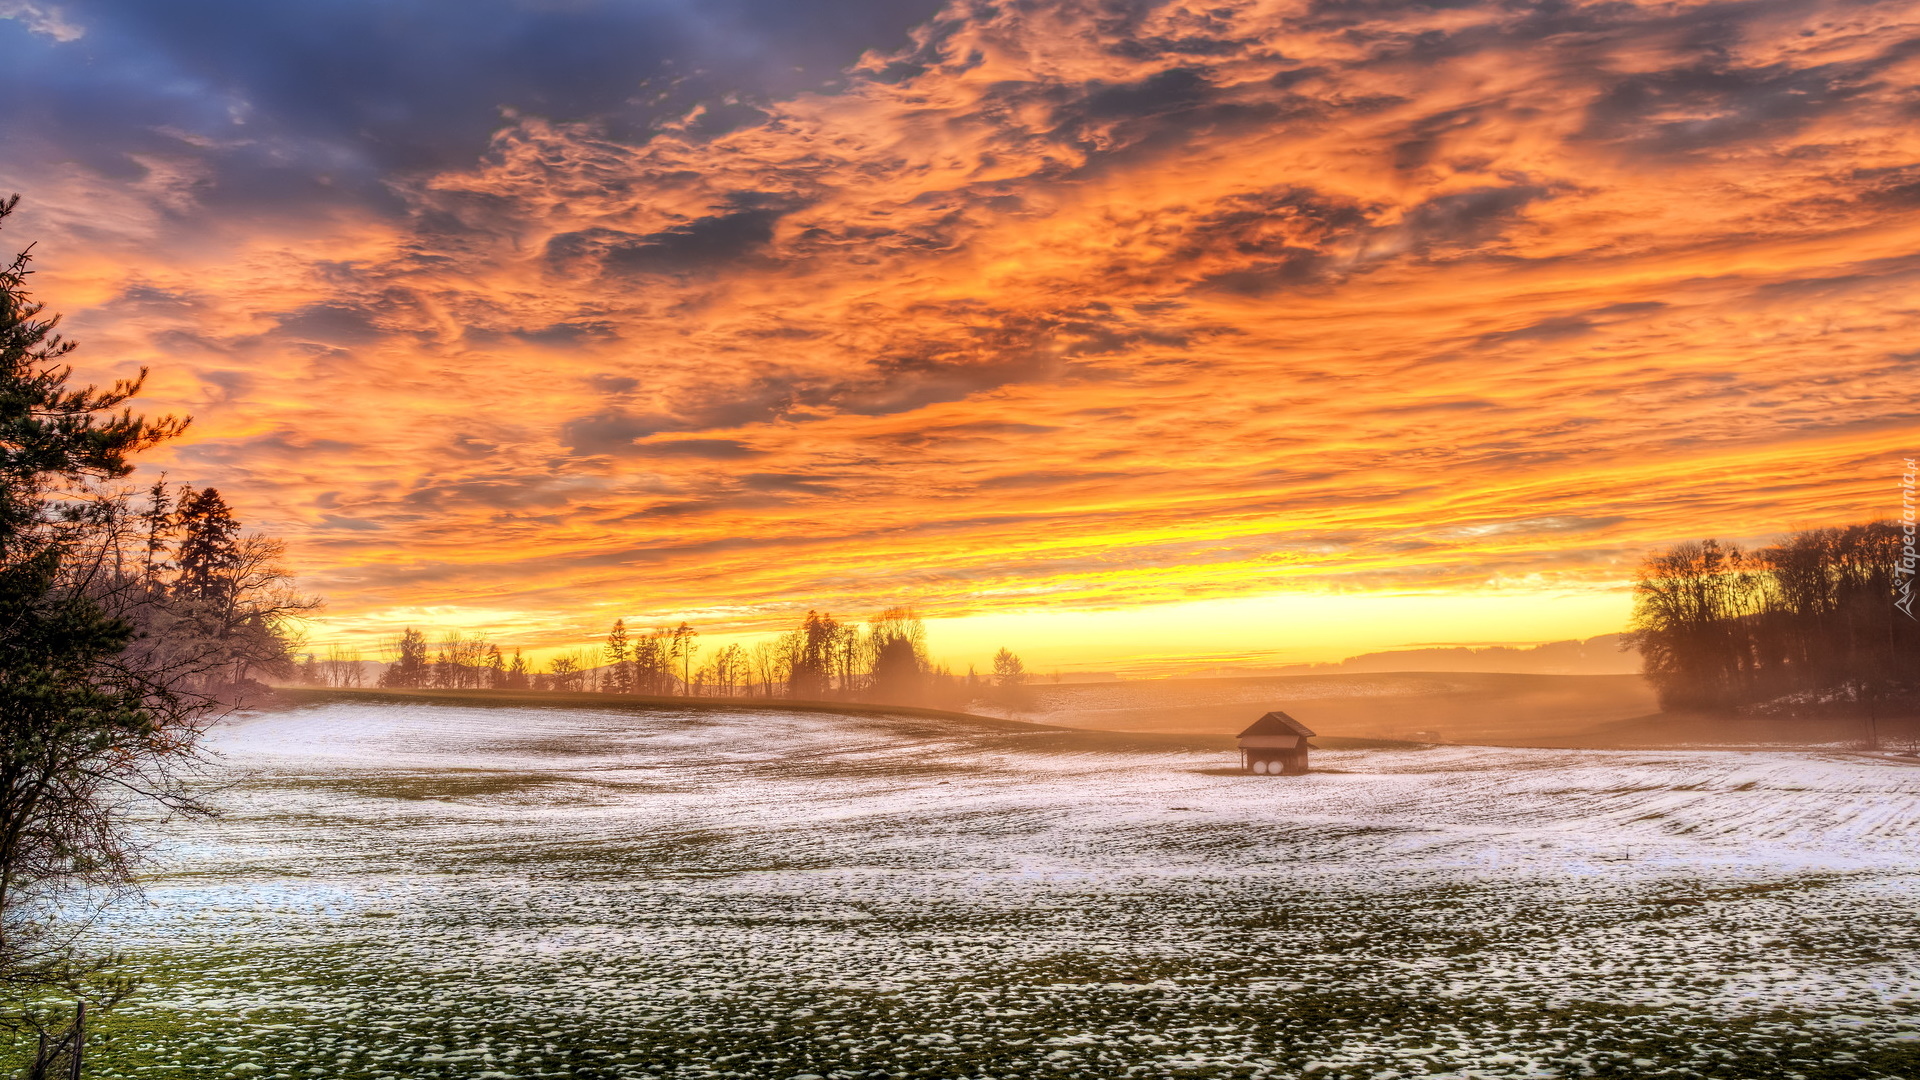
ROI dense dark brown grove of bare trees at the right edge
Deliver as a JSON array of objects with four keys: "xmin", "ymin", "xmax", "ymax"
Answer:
[{"xmin": 1626, "ymin": 521, "xmax": 1920, "ymax": 715}]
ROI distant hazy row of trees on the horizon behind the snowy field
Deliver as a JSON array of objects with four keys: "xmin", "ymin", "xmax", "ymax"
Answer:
[{"xmin": 357, "ymin": 607, "xmax": 1025, "ymax": 709}]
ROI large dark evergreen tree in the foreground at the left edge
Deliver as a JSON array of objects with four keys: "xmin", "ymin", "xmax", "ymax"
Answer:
[{"xmin": 0, "ymin": 196, "xmax": 198, "ymax": 986}]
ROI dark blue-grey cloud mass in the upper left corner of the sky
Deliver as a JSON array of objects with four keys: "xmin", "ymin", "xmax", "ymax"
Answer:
[{"xmin": 0, "ymin": 0, "xmax": 937, "ymax": 204}]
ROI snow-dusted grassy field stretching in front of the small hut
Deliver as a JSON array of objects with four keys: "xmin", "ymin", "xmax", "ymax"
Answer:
[{"xmin": 92, "ymin": 703, "xmax": 1920, "ymax": 1080}]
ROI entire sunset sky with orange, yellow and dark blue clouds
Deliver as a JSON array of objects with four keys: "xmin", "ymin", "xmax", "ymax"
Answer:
[{"xmin": 0, "ymin": 0, "xmax": 1920, "ymax": 673}]
